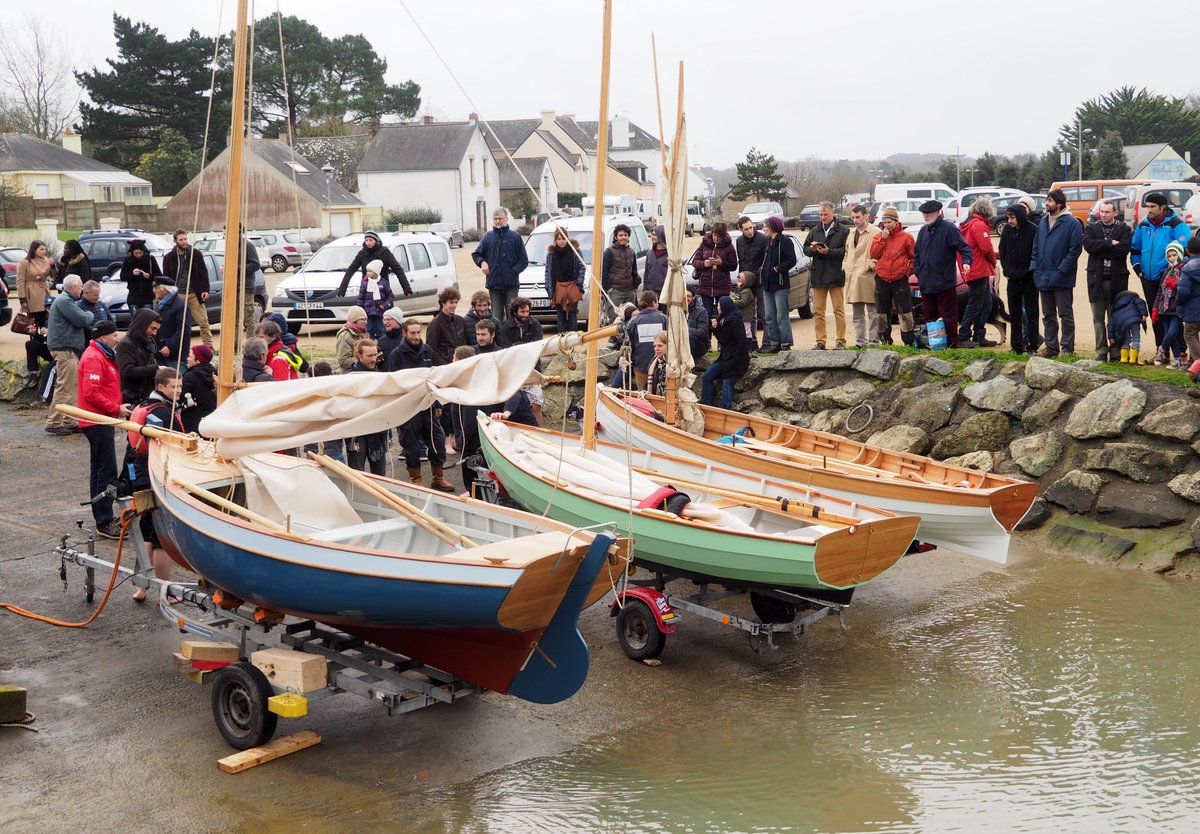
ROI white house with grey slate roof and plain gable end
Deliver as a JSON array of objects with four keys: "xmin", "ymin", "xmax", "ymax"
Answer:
[{"xmin": 358, "ymin": 121, "xmax": 500, "ymax": 229}]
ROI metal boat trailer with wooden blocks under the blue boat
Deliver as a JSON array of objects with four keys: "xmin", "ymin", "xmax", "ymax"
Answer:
[{"xmin": 54, "ymin": 498, "xmax": 482, "ymax": 750}]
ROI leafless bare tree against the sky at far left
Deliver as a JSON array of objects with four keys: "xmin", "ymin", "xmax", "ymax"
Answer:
[{"xmin": 0, "ymin": 17, "xmax": 79, "ymax": 140}]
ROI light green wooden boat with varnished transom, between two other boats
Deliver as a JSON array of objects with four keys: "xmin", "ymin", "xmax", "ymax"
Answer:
[{"xmin": 479, "ymin": 414, "xmax": 920, "ymax": 590}]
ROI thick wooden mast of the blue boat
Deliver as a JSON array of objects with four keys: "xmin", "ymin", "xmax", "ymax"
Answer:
[{"xmin": 217, "ymin": 0, "xmax": 248, "ymax": 403}]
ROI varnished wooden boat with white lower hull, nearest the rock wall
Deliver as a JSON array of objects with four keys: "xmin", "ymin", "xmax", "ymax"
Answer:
[{"xmin": 596, "ymin": 388, "xmax": 1038, "ymax": 564}]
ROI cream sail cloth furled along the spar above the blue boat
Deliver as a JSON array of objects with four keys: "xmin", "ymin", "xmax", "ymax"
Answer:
[{"xmin": 200, "ymin": 332, "xmax": 582, "ymax": 457}]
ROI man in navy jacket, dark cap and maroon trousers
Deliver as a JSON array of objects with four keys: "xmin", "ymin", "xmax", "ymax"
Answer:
[{"xmin": 912, "ymin": 200, "xmax": 971, "ymax": 348}]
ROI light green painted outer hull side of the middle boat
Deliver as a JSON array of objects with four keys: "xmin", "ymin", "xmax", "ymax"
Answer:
[{"xmin": 479, "ymin": 431, "xmax": 835, "ymax": 590}]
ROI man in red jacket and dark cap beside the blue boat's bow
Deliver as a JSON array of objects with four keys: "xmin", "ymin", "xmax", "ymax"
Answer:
[{"xmin": 76, "ymin": 322, "xmax": 130, "ymax": 539}]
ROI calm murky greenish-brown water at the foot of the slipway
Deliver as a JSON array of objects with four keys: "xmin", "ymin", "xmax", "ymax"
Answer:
[{"xmin": 426, "ymin": 547, "xmax": 1200, "ymax": 832}]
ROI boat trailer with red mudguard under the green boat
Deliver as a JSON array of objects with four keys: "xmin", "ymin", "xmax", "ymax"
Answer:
[{"xmin": 608, "ymin": 571, "xmax": 853, "ymax": 660}]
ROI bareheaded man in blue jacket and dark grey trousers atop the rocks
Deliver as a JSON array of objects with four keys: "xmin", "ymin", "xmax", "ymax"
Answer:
[{"xmin": 1030, "ymin": 188, "xmax": 1084, "ymax": 356}]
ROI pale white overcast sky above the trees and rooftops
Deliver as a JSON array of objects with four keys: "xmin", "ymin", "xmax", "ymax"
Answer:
[{"xmin": 42, "ymin": 0, "xmax": 1200, "ymax": 167}]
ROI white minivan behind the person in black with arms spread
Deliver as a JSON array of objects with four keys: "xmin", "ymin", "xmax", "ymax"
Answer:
[{"xmin": 272, "ymin": 232, "xmax": 458, "ymax": 334}]
